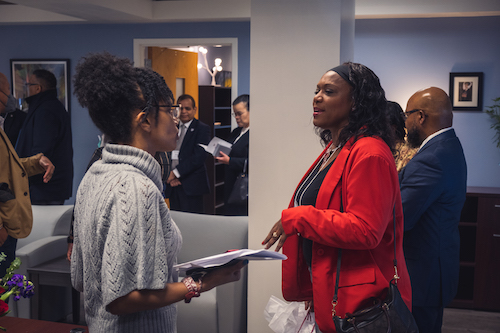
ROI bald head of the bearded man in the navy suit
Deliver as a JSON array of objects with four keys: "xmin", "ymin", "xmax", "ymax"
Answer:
[{"xmin": 406, "ymin": 87, "xmax": 453, "ymax": 146}]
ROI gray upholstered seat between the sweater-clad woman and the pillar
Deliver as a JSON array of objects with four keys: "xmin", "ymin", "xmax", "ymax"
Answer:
[{"xmin": 171, "ymin": 211, "xmax": 248, "ymax": 333}]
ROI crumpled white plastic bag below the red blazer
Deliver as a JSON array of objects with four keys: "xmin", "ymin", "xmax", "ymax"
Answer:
[{"xmin": 264, "ymin": 296, "xmax": 315, "ymax": 333}]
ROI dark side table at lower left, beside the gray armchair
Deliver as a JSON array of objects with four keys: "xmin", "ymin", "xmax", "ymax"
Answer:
[{"xmin": 28, "ymin": 256, "xmax": 80, "ymax": 324}]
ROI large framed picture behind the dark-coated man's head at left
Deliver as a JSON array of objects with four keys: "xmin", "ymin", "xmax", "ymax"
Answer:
[{"xmin": 10, "ymin": 59, "xmax": 70, "ymax": 112}]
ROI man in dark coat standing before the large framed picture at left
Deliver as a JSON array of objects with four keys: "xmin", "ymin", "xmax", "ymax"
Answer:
[{"xmin": 16, "ymin": 69, "xmax": 73, "ymax": 205}]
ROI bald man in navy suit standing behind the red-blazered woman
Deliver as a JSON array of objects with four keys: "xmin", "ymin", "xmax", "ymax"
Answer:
[{"xmin": 399, "ymin": 87, "xmax": 467, "ymax": 333}]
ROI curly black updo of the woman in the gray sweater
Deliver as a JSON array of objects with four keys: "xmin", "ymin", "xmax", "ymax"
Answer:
[{"xmin": 73, "ymin": 52, "xmax": 173, "ymax": 143}]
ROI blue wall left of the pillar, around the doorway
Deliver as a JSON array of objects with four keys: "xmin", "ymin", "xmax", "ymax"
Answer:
[{"xmin": 0, "ymin": 22, "xmax": 250, "ymax": 203}]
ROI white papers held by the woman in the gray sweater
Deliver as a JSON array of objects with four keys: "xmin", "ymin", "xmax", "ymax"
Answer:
[{"xmin": 174, "ymin": 249, "xmax": 287, "ymax": 272}]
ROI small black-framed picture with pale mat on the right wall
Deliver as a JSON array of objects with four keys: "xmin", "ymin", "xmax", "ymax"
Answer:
[{"xmin": 450, "ymin": 72, "xmax": 483, "ymax": 111}]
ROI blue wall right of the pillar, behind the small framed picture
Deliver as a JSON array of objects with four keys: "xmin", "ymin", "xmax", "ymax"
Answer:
[{"xmin": 354, "ymin": 16, "xmax": 500, "ymax": 187}]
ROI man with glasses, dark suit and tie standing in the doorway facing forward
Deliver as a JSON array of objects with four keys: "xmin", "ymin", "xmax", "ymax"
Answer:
[{"xmin": 165, "ymin": 95, "xmax": 210, "ymax": 213}]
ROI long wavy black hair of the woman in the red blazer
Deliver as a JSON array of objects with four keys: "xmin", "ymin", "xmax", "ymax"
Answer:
[{"xmin": 318, "ymin": 62, "xmax": 394, "ymax": 150}]
